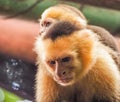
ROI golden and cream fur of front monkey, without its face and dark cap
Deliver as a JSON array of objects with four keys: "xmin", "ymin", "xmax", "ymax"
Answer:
[{"xmin": 36, "ymin": 30, "xmax": 120, "ymax": 102}]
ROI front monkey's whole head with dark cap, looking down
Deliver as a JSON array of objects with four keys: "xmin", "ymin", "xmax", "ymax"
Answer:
[{"xmin": 36, "ymin": 21, "xmax": 95, "ymax": 86}]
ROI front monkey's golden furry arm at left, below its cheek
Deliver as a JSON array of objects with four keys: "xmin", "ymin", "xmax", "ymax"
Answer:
[{"xmin": 36, "ymin": 67, "xmax": 58, "ymax": 102}]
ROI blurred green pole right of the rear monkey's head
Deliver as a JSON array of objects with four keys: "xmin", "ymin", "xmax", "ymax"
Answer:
[{"xmin": 81, "ymin": 5, "xmax": 120, "ymax": 33}]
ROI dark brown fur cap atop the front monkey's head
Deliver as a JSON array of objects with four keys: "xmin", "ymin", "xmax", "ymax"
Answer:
[{"xmin": 44, "ymin": 21, "xmax": 78, "ymax": 40}]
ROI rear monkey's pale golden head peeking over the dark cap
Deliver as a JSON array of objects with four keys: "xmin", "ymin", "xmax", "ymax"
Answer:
[{"xmin": 40, "ymin": 4, "xmax": 87, "ymax": 34}]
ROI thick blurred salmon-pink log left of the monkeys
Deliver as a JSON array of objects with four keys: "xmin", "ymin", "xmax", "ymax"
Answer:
[{"xmin": 0, "ymin": 17, "xmax": 39, "ymax": 63}]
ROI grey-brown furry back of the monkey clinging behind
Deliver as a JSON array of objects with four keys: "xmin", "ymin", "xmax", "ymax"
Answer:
[{"xmin": 87, "ymin": 25, "xmax": 120, "ymax": 68}]
